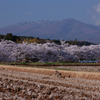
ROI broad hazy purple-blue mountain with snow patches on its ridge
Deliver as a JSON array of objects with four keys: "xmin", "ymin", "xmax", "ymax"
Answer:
[{"xmin": 0, "ymin": 18, "xmax": 100, "ymax": 43}]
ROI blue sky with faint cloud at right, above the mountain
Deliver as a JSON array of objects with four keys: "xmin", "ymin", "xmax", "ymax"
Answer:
[{"xmin": 0, "ymin": 0, "xmax": 100, "ymax": 28}]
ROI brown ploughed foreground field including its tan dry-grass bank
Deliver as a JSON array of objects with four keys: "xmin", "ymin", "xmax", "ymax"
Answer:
[{"xmin": 0, "ymin": 65, "xmax": 100, "ymax": 100}]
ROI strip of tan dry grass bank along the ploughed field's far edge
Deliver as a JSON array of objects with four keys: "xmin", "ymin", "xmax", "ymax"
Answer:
[{"xmin": 0, "ymin": 65, "xmax": 100, "ymax": 80}]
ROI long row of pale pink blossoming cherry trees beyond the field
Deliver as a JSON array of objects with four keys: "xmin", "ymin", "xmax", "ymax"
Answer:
[{"xmin": 0, "ymin": 40, "xmax": 100, "ymax": 62}]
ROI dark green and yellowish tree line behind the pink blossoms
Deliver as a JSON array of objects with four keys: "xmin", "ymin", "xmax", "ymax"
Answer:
[{"xmin": 0, "ymin": 33, "xmax": 94, "ymax": 46}]
